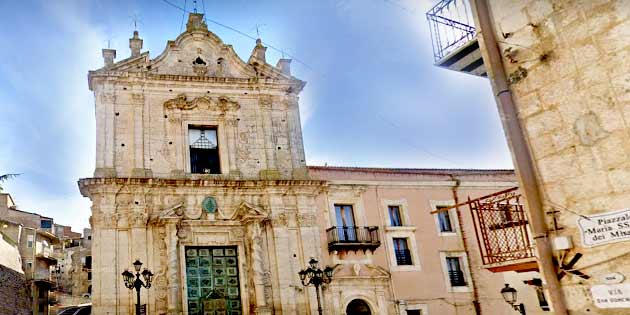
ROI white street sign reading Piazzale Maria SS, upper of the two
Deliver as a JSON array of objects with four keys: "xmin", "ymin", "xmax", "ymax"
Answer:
[{"xmin": 577, "ymin": 209, "xmax": 630, "ymax": 247}]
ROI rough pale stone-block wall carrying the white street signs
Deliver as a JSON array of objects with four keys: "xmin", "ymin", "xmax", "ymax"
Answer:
[{"xmin": 474, "ymin": 0, "xmax": 630, "ymax": 314}]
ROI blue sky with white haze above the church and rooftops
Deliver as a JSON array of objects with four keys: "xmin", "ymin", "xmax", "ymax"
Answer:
[{"xmin": 0, "ymin": 0, "xmax": 512, "ymax": 230}]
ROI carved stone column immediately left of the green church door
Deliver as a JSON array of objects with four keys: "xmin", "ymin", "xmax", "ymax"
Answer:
[{"xmin": 166, "ymin": 222, "xmax": 182, "ymax": 315}]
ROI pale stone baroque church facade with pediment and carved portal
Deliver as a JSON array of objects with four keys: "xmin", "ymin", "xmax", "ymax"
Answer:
[{"xmin": 79, "ymin": 14, "xmax": 324, "ymax": 314}]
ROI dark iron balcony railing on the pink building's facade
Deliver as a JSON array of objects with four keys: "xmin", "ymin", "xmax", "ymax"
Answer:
[{"xmin": 326, "ymin": 226, "xmax": 381, "ymax": 251}]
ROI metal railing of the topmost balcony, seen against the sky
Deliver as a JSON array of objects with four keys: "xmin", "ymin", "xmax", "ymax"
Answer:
[{"xmin": 426, "ymin": 0, "xmax": 477, "ymax": 62}]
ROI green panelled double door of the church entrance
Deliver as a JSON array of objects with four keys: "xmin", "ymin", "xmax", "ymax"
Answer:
[{"xmin": 186, "ymin": 246, "xmax": 243, "ymax": 315}]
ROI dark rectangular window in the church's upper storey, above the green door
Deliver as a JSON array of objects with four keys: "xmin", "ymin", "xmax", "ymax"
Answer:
[{"xmin": 188, "ymin": 126, "xmax": 221, "ymax": 174}]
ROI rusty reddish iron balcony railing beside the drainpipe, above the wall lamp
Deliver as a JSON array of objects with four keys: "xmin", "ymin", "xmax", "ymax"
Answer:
[{"xmin": 435, "ymin": 187, "xmax": 538, "ymax": 272}]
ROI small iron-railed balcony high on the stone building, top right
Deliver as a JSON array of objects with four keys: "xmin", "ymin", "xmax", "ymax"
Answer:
[{"xmin": 426, "ymin": 0, "xmax": 487, "ymax": 77}]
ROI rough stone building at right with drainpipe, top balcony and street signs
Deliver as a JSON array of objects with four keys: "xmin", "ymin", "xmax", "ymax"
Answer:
[{"xmin": 427, "ymin": 0, "xmax": 630, "ymax": 315}]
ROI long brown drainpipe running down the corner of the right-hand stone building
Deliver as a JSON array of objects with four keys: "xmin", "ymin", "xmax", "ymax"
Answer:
[{"xmin": 470, "ymin": 0, "xmax": 568, "ymax": 315}]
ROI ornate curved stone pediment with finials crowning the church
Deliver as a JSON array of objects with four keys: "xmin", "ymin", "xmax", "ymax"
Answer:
[{"xmin": 88, "ymin": 13, "xmax": 305, "ymax": 93}]
